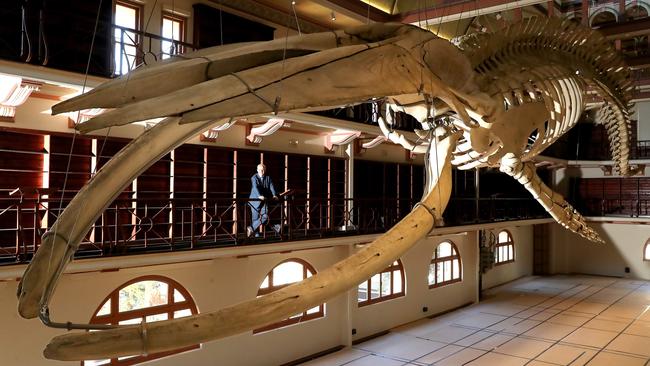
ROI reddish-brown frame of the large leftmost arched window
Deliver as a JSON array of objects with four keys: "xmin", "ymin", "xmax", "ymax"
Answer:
[{"xmin": 81, "ymin": 275, "xmax": 201, "ymax": 366}]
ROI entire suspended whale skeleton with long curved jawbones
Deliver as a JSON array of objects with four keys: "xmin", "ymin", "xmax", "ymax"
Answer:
[{"xmin": 18, "ymin": 18, "xmax": 634, "ymax": 360}]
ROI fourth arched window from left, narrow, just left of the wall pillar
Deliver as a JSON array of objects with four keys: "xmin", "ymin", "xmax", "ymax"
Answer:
[{"xmin": 429, "ymin": 241, "xmax": 461, "ymax": 288}]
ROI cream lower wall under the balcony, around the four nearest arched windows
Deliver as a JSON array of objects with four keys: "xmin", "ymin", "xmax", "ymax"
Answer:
[{"xmin": 0, "ymin": 228, "xmax": 502, "ymax": 366}]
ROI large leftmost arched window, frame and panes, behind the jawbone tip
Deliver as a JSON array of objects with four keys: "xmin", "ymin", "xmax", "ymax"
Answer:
[{"xmin": 81, "ymin": 276, "xmax": 200, "ymax": 366}]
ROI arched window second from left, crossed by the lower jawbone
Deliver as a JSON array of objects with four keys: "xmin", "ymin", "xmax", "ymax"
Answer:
[{"xmin": 253, "ymin": 258, "xmax": 325, "ymax": 333}]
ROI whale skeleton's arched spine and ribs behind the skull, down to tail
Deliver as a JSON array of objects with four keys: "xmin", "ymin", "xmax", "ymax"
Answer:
[{"xmin": 458, "ymin": 18, "xmax": 633, "ymax": 176}]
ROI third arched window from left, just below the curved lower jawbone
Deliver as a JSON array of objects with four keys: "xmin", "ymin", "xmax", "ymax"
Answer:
[{"xmin": 357, "ymin": 259, "xmax": 405, "ymax": 306}]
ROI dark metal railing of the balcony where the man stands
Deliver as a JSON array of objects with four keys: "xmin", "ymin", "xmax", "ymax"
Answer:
[{"xmin": 0, "ymin": 190, "xmax": 547, "ymax": 264}]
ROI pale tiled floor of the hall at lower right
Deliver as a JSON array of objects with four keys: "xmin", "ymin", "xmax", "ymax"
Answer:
[{"xmin": 304, "ymin": 276, "xmax": 650, "ymax": 366}]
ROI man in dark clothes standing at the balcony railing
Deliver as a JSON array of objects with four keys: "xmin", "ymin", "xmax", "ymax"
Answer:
[{"xmin": 246, "ymin": 164, "xmax": 280, "ymax": 237}]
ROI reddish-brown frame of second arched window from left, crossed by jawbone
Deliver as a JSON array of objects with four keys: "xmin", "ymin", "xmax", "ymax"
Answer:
[{"xmin": 253, "ymin": 258, "xmax": 325, "ymax": 334}]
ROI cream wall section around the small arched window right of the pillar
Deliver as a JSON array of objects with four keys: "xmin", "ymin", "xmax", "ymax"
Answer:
[{"xmin": 482, "ymin": 225, "xmax": 533, "ymax": 289}]
